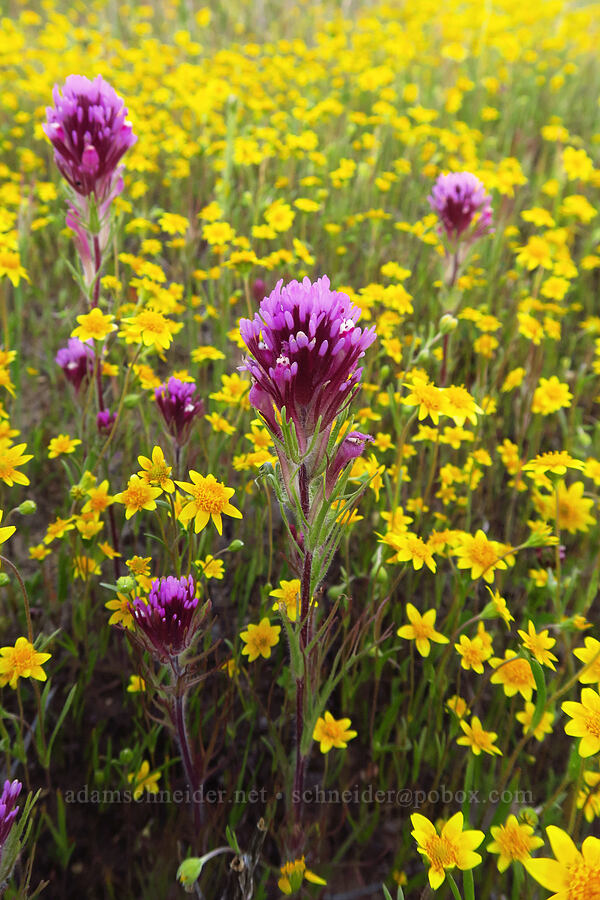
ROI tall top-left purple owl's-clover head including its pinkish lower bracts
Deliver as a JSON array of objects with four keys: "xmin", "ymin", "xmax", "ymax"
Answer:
[{"xmin": 43, "ymin": 75, "xmax": 137, "ymax": 290}]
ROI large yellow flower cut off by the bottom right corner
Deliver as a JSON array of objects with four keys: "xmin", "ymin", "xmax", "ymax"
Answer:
[{"xmin": 523, "ymin": 825, "xmax": 600, "ymax": 900}]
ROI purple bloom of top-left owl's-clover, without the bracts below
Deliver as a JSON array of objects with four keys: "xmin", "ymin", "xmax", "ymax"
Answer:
[{"xmin": 43, "ymin": 75, "xmax": 137, "ymax": 203}]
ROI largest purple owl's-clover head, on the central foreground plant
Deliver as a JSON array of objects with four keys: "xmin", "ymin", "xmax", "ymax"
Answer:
[{"xmin": 240, "ymin": 275, "xmax": 376, "ymax": 452}]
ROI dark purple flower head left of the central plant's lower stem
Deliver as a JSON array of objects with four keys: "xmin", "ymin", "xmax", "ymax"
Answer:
[{"xmin": 131, "ymin": 575, "xmax": 198, "ymax": 662}]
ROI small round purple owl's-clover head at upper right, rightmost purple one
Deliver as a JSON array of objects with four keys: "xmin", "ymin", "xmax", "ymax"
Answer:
[{"xmin": 427, "ymin": 172, "xmax": 493, "ymax": 243}]
